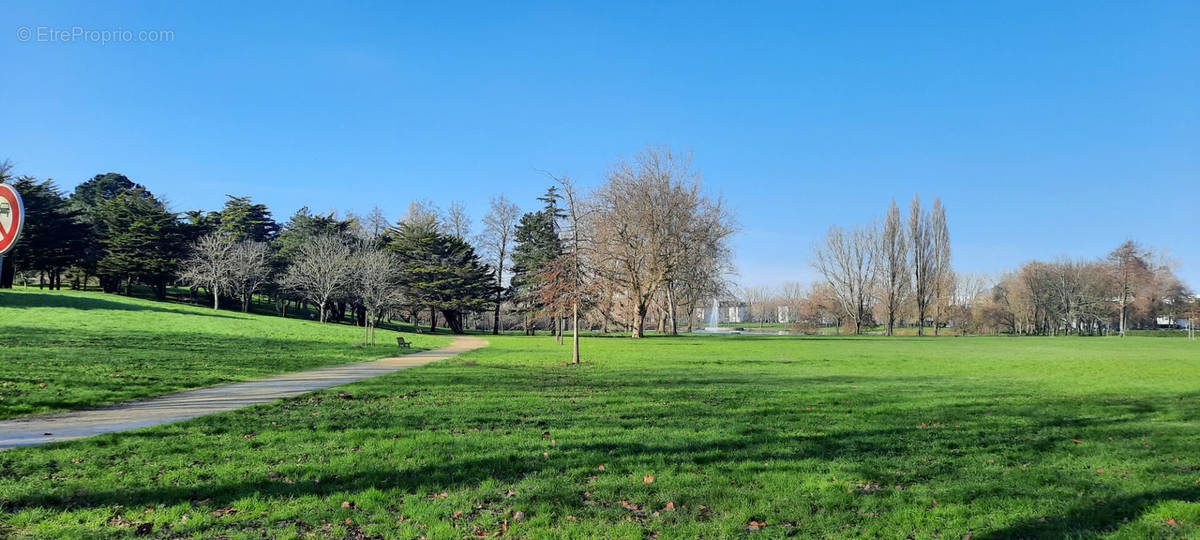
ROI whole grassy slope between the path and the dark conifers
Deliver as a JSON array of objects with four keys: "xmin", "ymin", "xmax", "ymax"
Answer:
[{"xmin": 0, "ymin": 292, "xmax": 449, "ymax": 418}]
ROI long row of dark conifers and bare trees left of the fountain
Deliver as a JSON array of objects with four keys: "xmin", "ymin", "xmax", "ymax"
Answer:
[{"xmin": 0, "ymin": 148, "xmax": 734, "ymax": 352}]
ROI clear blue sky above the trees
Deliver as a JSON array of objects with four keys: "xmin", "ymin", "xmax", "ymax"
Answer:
[{"xmin": 0, "ymin": 1, "xmax": 1200, "ymax": 287}]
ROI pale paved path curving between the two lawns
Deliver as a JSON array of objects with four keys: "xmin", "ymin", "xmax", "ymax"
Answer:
[{"xmin": 0, "ymin": 337, "xmax": 487, "ymax": 450}]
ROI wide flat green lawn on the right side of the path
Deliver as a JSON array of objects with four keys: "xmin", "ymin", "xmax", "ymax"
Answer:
[{"xmin": 0, "ymin": 336, "xmax": 1200, "ymax": 539}]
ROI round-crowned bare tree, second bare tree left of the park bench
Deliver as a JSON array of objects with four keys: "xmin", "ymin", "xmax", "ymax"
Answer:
[{"xmin": 283, "ymin": 234, "xmax": 354, "ymax": 323}]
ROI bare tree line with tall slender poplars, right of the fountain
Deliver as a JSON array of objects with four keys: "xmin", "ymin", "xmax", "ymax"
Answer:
[{"xmin": 777, "ymin": 197, "xmax": 1200, "ymax": 336}]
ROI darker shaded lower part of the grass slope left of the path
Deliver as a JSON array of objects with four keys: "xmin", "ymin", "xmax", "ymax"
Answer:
[{"xmin": 0, "ymin": 326, "xmax": 428, "ymax": 418}]
